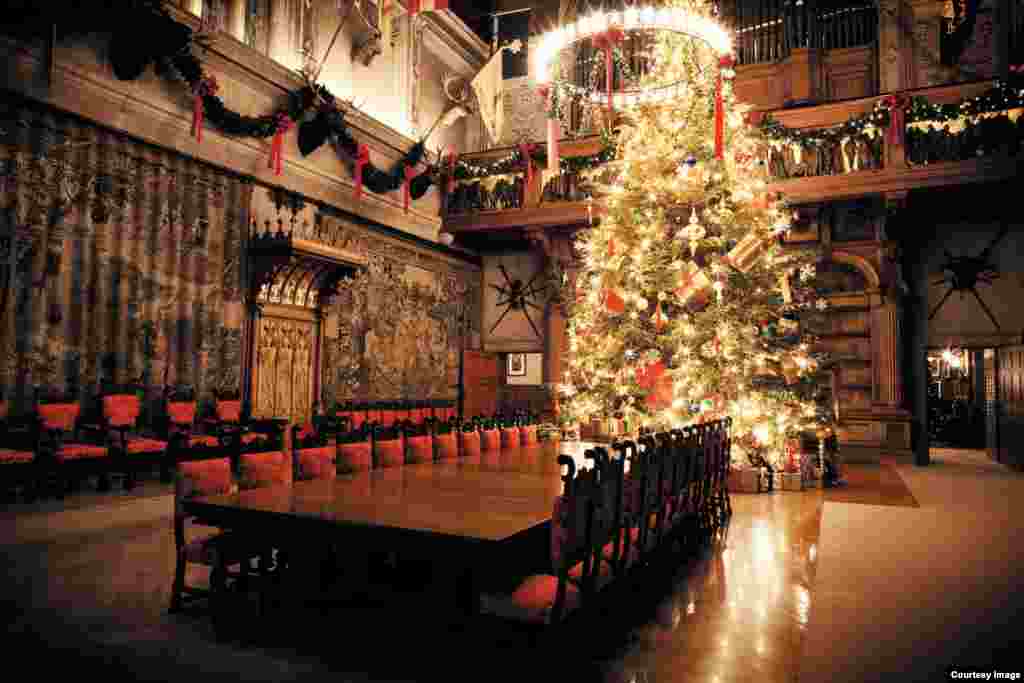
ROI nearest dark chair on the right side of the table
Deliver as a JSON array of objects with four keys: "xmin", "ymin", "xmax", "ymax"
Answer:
[{"xmin": 481, "ymin": 456, "xmax": 606, "ymax": 625}]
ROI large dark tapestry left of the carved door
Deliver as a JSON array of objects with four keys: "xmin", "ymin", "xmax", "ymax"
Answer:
[{"xmin": 0, "ymin": 100, "xmax": 251, "ymax": 418}]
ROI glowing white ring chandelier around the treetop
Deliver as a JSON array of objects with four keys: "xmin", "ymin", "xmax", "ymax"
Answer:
[{"xmin": 534, "ymin": 7, "xmax": 732, "ymax": 106}]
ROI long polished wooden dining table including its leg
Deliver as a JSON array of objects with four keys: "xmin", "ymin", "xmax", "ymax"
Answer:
[{"xmin": 183, "ymin": 441, "xmax": 598, "ymax": 613}]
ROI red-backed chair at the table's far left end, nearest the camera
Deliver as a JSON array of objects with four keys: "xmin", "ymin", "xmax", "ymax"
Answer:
[{"xmin": 165, "ymin": 458, "xmax": 256, "ymax": 611}]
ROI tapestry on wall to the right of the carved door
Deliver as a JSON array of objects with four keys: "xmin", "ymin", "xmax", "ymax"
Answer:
[{"xmin": 323, "ymin": 255, "xmax": 479, "ymax": 407}]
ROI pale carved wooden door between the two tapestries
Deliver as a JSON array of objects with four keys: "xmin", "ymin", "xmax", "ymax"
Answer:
[{"xmin": 253, "ymin": 306, "xmax": 319, "ymax": 422}]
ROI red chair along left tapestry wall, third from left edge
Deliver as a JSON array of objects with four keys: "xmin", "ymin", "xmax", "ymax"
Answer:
[{"xmin": 100, "ymin": 387, "xmax": 168, "ymax": 489}]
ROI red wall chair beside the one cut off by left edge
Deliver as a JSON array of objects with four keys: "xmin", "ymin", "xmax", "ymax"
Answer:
[{"xmin": 35, "ymin": 397, "xmax": 113, "ymax": 499}]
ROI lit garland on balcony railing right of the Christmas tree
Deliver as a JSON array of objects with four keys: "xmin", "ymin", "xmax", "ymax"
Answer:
[{"xmin": 760, "ymin": 71, "xmax": 1024, "ymax": 172}]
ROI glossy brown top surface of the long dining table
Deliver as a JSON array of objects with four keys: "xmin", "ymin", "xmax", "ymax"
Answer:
[{"xmin": 184, "ymin": 443, "xmax": 562, "ymax": 542}]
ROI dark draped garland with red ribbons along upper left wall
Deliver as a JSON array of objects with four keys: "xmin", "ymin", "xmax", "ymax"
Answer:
[{"xmin": 20, "ymin": 0, "xmax": 436, "ymax": 199}]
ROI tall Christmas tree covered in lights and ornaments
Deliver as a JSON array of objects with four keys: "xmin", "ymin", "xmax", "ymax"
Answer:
[{"xmin": 562, "ymin": 0, "xmax": 830, "ymax": 464}]
